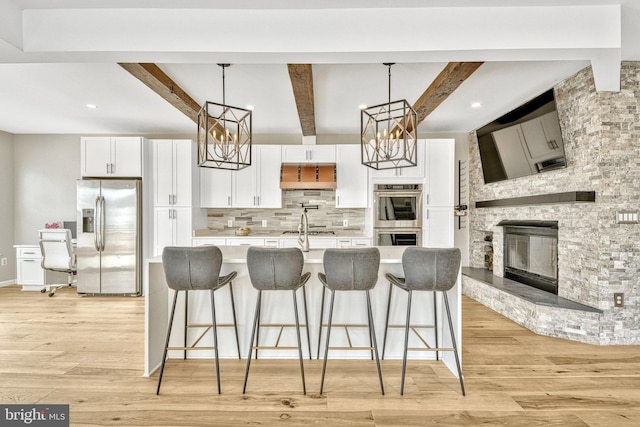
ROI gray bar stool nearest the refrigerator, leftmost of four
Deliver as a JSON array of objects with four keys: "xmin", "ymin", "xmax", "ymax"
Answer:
[{"xmin": 156, "ymin": 246, "xmax": 240, "ymax": 394}]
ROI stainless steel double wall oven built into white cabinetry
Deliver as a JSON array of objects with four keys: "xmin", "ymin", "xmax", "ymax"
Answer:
[{"xmin": 373, "ymin": 184, "xmax": 422, "ymax": 246}]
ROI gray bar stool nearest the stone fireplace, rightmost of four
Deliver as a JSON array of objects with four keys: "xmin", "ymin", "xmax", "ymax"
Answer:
[{"xmin": 383, "ymin": 247, "xmax": 465, "ymax": 396}]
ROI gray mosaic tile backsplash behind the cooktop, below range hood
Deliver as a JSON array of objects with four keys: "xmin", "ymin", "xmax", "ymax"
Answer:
[{"xmin": 207, "ymin": 190, "xmax": 366, "ymax": 231}]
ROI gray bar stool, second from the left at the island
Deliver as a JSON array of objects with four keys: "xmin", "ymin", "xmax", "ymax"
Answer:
[{"xmin": 242, "ymin": 246, "xmax": 311, "ymax": 394}]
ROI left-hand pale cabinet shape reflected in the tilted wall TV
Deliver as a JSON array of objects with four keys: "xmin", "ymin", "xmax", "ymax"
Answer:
[{"xmin": 491, "ymin": 125, "xmax": 534, "ymax": 178}]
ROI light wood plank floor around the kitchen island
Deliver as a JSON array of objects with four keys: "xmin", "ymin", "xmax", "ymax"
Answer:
[{"xmin": 0, "ymin": 286, "xmax": 640, "ymax": 427}]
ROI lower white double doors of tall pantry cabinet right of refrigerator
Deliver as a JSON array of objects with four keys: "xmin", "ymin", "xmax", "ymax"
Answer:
[{"xmin": 153, "ymin": 206, "xmax": 193, "ymax": 256}]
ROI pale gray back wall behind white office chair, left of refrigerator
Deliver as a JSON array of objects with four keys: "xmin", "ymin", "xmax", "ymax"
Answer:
[{"xmin": 13, "ymin": 135, "xmax": 80, "ymax": 244}]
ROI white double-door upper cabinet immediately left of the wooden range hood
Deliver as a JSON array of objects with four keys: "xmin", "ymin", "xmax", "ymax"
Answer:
[{"xmin": 231, "ymin": 145, "xmax": 282, "ymax": 208}]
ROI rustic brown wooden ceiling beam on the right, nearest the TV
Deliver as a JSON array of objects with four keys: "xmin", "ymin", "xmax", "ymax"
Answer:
[{"xmin": 413, "ymin": 62, "xmax": 484, "ymax": 130}]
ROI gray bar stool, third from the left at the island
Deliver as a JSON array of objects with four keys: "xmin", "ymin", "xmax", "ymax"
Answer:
[{"xmin": 318, "ymin": 247, "xmax": 384, "ymax": 395}]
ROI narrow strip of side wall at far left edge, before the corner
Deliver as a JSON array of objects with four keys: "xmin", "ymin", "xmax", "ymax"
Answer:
[{"xmin": 0, "ymin": 131, "xmax": 16, "ymax": 285}]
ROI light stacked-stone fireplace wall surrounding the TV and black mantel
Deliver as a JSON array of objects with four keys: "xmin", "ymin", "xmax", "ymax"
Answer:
[{"xmin": 469, "ymin": 62, "xmax": 640, "ymax": 344}]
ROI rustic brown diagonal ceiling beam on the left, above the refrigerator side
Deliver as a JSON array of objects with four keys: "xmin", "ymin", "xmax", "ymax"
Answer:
[{"xmin": 119, "ymin": 63, "xmax": 200, "ymax": 123}]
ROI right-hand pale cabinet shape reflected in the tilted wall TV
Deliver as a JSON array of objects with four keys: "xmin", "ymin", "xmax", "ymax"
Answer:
[{"xmin": 520, "ymin": 111, "xmax": 562, "ymax": 163}]
